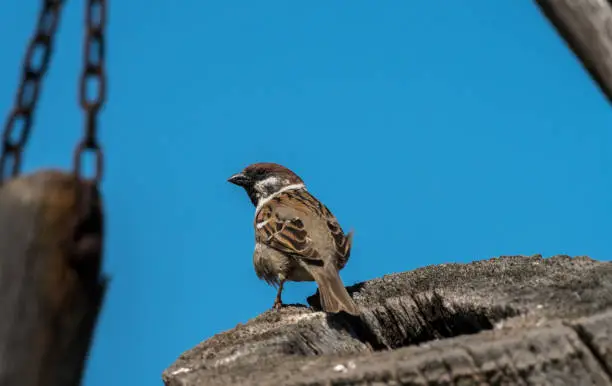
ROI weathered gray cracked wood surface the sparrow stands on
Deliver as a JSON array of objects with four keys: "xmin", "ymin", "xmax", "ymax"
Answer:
[{"xmin": 162, "ymin": 256, "xmax": 612, "ymax": 386}]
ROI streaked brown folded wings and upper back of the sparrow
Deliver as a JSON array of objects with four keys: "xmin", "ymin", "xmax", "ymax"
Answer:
[{"xmin": 255, "ymin": 190, "xmax": 352, "ymax": 269}]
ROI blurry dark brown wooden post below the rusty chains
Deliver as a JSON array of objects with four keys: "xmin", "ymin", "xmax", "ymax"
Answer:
[{"xmin": 0, "ymin": 171, "xmax": 106, "ymax": 386}]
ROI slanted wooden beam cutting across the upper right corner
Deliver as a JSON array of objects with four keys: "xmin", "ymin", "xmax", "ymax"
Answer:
[{"xmin": 535, "ymin": 0, "xmax": 612, "ymax": 103}]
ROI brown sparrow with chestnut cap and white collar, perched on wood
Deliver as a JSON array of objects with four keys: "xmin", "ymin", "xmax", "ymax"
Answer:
[{"xmin": 228, "ymin": 162, "xmax": 359, "ymax": 315}]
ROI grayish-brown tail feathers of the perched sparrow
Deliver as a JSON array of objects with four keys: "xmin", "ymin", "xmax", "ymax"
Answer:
[{"xmin": 310, "ymin": 264, "xmax": 359, "ymax": 315}]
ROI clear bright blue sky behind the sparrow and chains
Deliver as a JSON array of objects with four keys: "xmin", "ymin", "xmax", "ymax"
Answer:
[{"xmin": 0, "ymin": 0, "xmax": 612, "ymax": 386}]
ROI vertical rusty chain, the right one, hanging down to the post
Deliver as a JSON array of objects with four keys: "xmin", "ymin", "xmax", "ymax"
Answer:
[{"xmin": 74, "ymin": 0, "xmax": 106, "ymax": 185}]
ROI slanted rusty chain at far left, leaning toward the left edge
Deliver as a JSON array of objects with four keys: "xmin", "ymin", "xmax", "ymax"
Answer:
[{"xmin": 0, "ymin": 0, "xmax": 64, "ymax": 184}]
